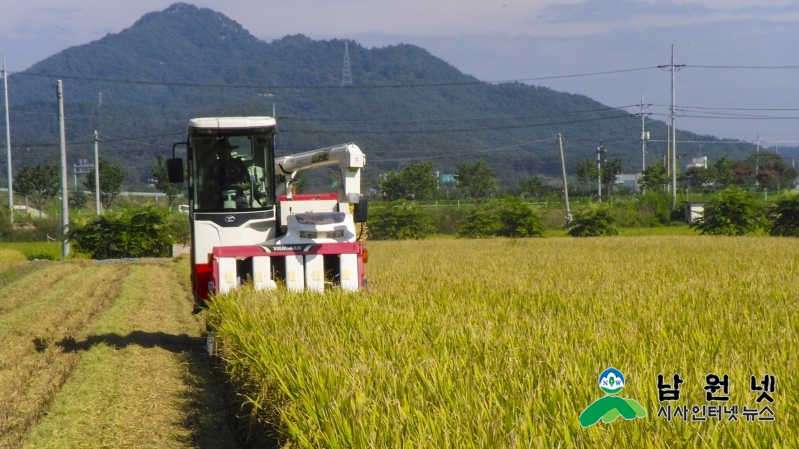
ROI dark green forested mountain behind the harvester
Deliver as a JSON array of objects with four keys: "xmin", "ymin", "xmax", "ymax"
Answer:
[{"xmin": 3, "ymin": 3, "xmax": 754, "ymax": 185}]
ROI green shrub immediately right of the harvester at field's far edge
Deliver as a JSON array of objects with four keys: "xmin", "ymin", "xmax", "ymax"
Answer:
[{"xmin": 369, "ymin": 200, "xmax": 435, "ymax": 240}]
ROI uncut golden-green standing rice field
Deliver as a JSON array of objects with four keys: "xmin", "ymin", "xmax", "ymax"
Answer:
[{"xmin": 209, "ymin": 236, "xmax": 799, "ymax": 448}]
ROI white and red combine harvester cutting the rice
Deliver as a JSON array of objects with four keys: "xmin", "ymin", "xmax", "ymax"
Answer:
[{"xmin": 167, "ymin": 117, "xmax": 368, "ymax": 305}]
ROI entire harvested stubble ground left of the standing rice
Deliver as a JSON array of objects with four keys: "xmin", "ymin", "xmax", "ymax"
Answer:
[{"xmin": 0, "ymin": 261, "xmax": 237, "ymax": 449}]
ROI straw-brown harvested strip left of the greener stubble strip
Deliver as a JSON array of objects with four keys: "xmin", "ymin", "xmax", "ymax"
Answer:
[{"xmin": 0, "ymin": 263, "xmax": 128, "ymax": 447}]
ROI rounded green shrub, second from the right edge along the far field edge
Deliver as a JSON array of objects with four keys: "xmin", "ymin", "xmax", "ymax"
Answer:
[{"xmin": 690, "ymin": 188, "xmax": 759, "ymax": 235}]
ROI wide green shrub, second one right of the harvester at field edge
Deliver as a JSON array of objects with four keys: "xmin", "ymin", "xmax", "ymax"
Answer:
[{"xmin": 457, "ymin": 197, "xmax": 543, "ymax": 238}]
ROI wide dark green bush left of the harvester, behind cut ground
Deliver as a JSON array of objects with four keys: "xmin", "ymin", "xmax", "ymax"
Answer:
[{"xmin": 66, "ymin": 207, "xmax": 175, "ymax": 259}]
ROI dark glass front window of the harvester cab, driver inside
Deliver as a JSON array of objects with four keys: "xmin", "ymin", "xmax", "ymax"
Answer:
[{"xmin": 192, "ymin": 135, "xmax": 273, "ymax": 210}]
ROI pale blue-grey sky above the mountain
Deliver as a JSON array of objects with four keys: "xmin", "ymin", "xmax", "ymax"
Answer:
[{"xmin": 0, "ymin": 0, "xmax": 799, "ymax": 146}]
